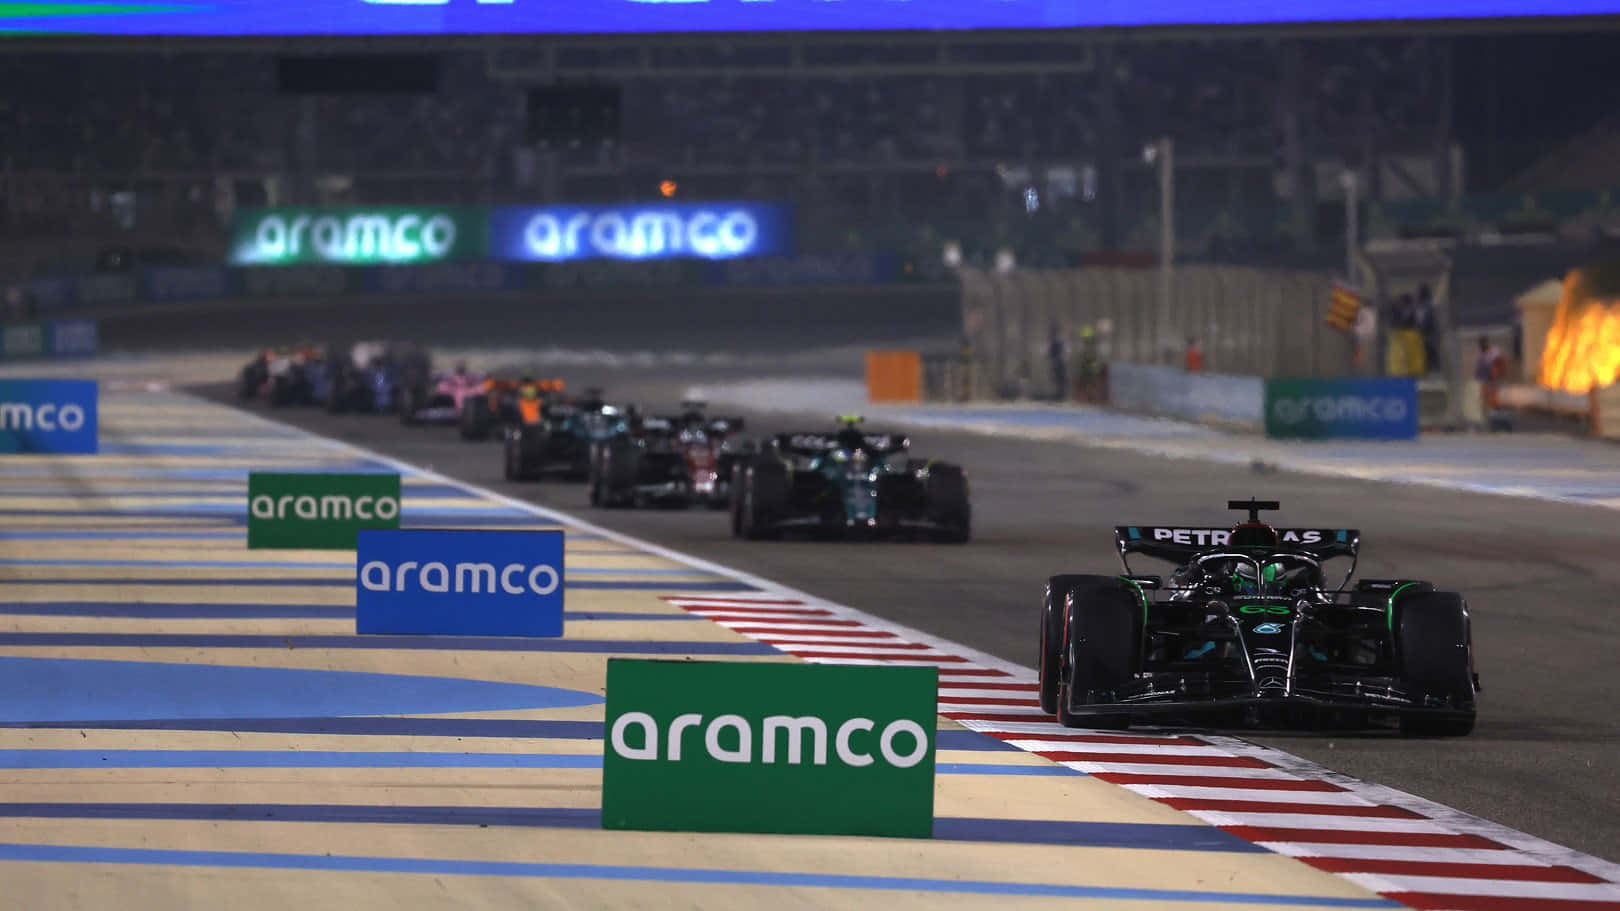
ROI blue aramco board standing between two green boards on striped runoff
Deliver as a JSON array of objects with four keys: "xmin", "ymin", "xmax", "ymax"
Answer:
[{"xmin": 355, "ymin": 528, "xmax": 564, "ymax": 637}]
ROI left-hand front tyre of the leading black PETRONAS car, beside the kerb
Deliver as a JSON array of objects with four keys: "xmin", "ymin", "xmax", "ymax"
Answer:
[{"xmin": 1058, "ymin": 585, "xmax": 1142, "ymax": 731}]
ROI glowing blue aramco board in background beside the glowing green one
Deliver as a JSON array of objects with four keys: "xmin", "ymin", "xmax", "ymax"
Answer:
[{"xmin": 489, "ymin": 203, "xmax": 792, "ymax": 263}]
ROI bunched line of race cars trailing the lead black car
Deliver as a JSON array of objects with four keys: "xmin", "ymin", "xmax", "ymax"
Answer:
[{"xmin": 238, "ymin": 342, "xmax": 972, "ymax": 543}]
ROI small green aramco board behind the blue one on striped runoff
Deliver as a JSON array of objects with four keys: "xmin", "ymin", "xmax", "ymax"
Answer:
[{"xmin": 248, "ymin": 472, "xmax": 400, "ymax": 551}]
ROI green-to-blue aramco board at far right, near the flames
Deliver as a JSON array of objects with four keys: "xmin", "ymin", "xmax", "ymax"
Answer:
[{"xmin": 1265, "ymin": 379, "xmax": 1418, "ymax": 439}]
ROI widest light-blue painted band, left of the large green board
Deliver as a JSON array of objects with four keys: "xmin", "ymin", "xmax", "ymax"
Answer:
[{"xmin": 0, "ymin": 657, "xmax": 603, "ymax": 725}]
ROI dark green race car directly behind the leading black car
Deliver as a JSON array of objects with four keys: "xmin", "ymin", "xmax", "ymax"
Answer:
[{"xmin": 731, "ymin": 418, "xmax": 972, "ymax": 543}]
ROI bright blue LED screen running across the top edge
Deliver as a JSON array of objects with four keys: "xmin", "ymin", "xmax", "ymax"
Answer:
[{"xmin": 0, "ymin": 0, "xmax": 1620, "ymax": 36}]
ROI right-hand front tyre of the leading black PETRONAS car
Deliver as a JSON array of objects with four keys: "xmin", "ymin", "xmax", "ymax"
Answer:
[{"xmin": 1395, "ymin": 592, "xmax": 1474, "ymax": 738}]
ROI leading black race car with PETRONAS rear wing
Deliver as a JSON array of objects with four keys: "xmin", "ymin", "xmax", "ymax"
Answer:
[{"xmin": 1040, "ymin": 499, "xmax": 1479, "ymax": 736}]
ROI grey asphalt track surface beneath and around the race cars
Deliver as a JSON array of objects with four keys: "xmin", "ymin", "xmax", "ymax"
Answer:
[{"xmin": 192, "ymin": 370, "xmax": 1620, "ymax": 861}]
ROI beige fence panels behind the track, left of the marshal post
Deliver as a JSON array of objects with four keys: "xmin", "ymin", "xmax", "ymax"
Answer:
[{"xmin": 952, "ymin": 266, "xmax": 1353, "ymax": 399}]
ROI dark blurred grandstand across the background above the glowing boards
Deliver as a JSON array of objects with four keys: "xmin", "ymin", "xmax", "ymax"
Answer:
[{"xmin": 0, "ymin": 32, "xmax": 1447, "ymax": 275}]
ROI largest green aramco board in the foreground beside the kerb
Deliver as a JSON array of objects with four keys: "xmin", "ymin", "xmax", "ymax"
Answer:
[{"xmin": 603, "ymin": 658, "xmax": 940, "ymax": 838}]
